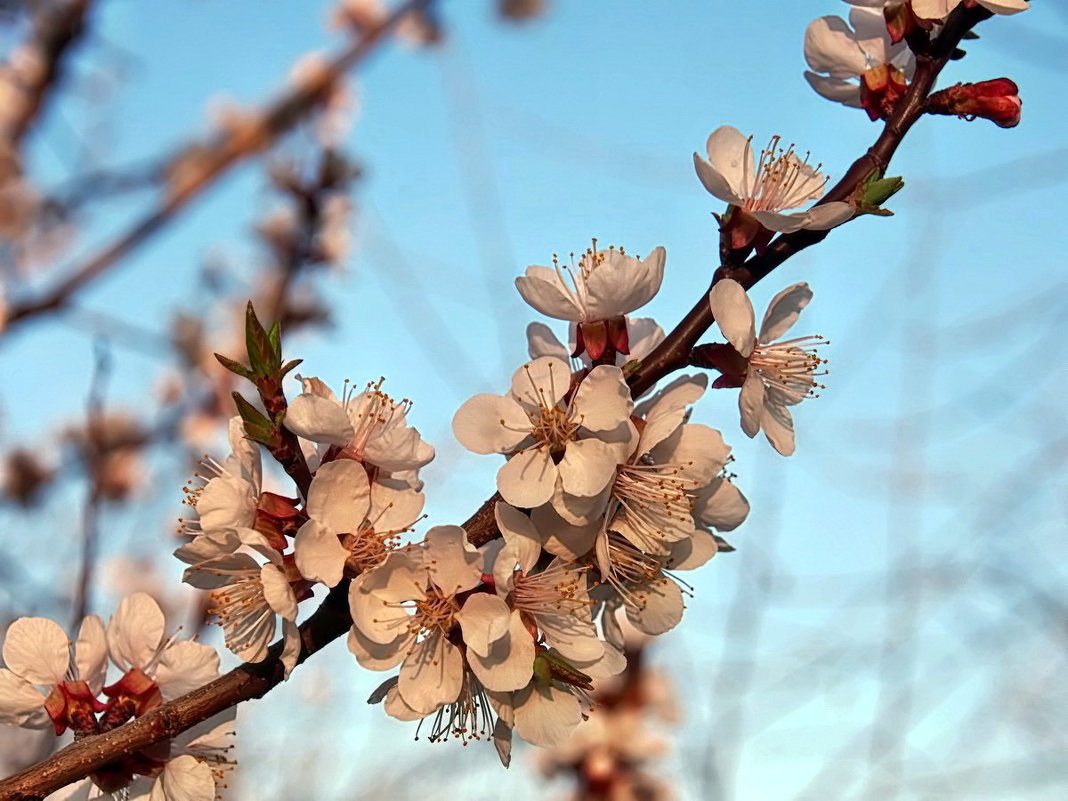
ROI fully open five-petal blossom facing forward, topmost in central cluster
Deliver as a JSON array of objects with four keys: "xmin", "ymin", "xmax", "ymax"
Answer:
[{"xmin": 453, "ymin": 357, "xmax": 633, "ymax": 508}]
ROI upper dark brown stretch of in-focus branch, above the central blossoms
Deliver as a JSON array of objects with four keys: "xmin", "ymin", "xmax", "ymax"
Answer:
[{"xmin": 629, "ymin": 4, "xmax": 993, "ymax": 396}]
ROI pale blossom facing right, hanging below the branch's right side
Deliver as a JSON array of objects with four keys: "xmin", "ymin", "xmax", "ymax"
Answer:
[{"xmin": 708, "ymin": 279, "xmax": 826, "ymax": 456}]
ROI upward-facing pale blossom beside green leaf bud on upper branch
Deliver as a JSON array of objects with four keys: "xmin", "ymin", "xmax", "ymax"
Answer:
[{"xmin": 693, "ymin": 125, "xmax": 853, "ymax": 238}]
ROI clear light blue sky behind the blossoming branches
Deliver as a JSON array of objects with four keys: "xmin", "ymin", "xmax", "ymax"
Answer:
[{"xmin": 0, "ymin": 0, "xmax": 1068, "ymax": 800}]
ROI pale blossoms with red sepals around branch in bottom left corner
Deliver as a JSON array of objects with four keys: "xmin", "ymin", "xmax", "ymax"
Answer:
[{"xmin": 0, "ymin": 593, "xmax": 236, "ymax": 801}]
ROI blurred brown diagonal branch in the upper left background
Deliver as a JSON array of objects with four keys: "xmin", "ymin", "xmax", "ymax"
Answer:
[{"xmin": 5, "ymin": 0, "xmax": 433, "ymax": 330}]
